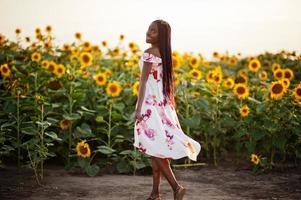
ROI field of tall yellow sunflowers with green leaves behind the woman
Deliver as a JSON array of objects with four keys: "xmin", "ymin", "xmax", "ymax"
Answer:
[{"xmin": 0, "ymin": 26, "xmax": 301, "ymax": 181}]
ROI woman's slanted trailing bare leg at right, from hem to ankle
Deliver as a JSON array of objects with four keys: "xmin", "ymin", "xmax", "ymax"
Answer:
[{"xmin": 154, "ymin": 157, "xmax": 180, "ymax": 191}]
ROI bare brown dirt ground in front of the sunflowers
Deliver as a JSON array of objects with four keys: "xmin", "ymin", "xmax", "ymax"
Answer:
[{"xmin": 0, "ymin": 161, "xmax": 301, "ymax": 200}]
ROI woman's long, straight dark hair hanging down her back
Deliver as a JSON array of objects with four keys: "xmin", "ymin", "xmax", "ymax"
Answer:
[{"xmin": 154, "ymin": 20, "xmax": 176, "ymax": 107}]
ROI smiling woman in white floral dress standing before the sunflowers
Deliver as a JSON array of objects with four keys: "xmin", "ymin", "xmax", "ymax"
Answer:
[{"xmin": 133, "ymin": 20, "xmax": 201, "ymax": 200}]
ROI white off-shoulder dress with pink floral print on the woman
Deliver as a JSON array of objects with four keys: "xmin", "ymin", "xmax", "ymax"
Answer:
[{"xmin": 133, "ymin": 52, "xmax": 201, "ymax": 161}]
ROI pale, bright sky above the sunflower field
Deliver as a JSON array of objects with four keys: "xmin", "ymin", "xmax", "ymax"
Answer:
[{"xmin": 0, "ymin": 0, "xmax": 301, "ymax": 58}]
